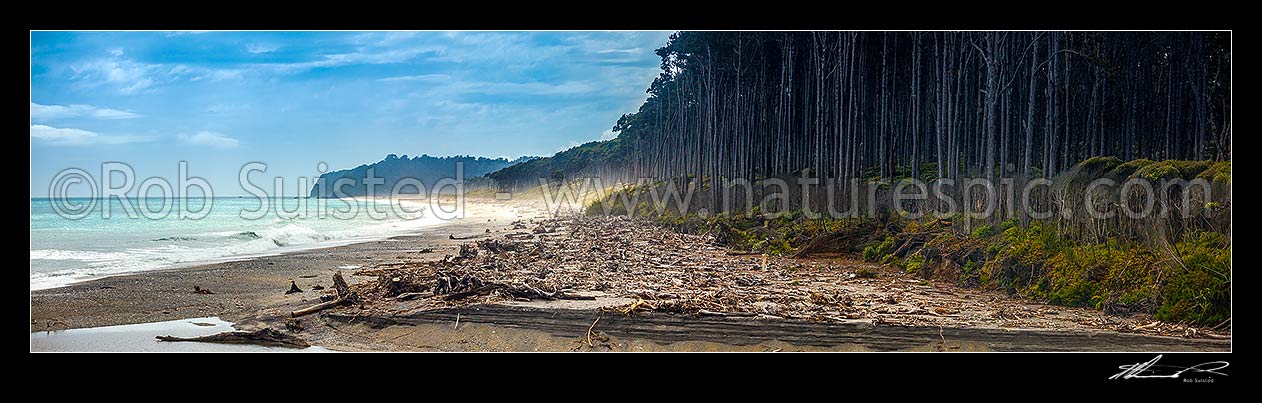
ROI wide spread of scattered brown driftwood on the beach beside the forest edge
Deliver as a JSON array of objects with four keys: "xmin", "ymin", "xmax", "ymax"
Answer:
[{"xmin": 293, "ymin": 216, "xmax": 1221, "ymax": 338}]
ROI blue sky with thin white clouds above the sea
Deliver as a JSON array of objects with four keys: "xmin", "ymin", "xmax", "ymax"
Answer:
[{"xmin": 30, "ymin": 32, "xmax": 670, "ymax": 197}]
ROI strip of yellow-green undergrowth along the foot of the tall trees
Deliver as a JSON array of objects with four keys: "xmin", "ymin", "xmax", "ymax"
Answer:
[{"xmin": 587, "ymin": 157, "xmax": 1232, "ymax": 326}]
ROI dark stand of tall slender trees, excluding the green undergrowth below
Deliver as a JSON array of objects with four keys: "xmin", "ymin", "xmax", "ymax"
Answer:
[{"xmin": 496, "ymin": 32, "xmax": 1230, "ymax": 189}]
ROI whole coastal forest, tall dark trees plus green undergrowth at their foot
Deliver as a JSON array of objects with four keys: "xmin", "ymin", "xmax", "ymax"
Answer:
[{"xmin": 487, "ymin": 32, "xmax": 1232, "ymax": 328}]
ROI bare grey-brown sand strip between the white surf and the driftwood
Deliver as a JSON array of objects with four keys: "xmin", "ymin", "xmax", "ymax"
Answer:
[{"xmin": 30, "ymin": 200, "xmax": 541, "ymax": 332}]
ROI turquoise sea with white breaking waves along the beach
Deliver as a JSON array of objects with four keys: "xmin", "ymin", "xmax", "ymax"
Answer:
[{"xmin": 30, "ymin": 197, "xmax": 452, "ymax": 289}]
